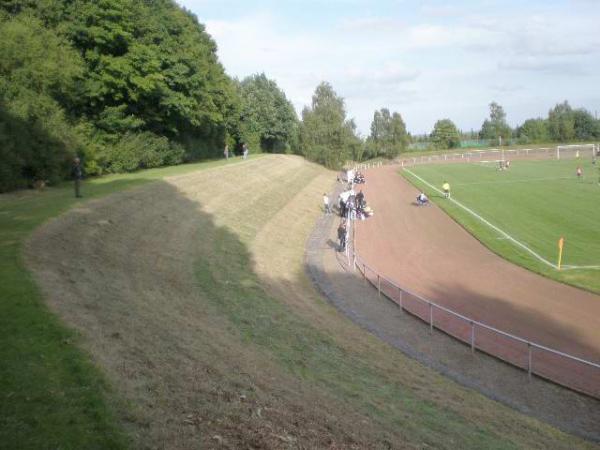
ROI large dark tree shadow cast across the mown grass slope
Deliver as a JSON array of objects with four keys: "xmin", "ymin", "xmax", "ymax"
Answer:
[{"xmin": 9, "ymin": 170, "xmax": 600, "ymax": 448}]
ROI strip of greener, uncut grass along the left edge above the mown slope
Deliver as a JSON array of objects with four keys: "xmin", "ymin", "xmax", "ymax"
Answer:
[{"xmin": 0, "ymin": 154, "xmax": 255, "ymax": 448}]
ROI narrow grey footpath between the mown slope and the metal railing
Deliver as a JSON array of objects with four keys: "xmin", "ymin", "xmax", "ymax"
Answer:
[{"xmin": 305, "ymin": 184, "xmax": 600, "ymax": 442}]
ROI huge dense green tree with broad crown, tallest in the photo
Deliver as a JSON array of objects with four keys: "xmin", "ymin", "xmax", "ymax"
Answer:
[{"xmin": 0, "ymin": 0, "xmax": 240, "ymax": 182}]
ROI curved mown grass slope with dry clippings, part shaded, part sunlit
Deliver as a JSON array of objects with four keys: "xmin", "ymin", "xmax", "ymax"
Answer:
[{"xmin": 0, "ymin": 156, "xmax": 594, "ymax": 449}]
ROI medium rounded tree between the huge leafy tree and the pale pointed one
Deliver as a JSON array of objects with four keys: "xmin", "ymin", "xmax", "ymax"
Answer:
[{"xmin": 238, "ymin": 73, "xmax": 298, "ymax": 152}]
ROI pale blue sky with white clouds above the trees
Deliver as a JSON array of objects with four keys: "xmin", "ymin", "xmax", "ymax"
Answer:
[{"xmin": 177, "ymin": 0, "xmax": 600, "ymax": 136}]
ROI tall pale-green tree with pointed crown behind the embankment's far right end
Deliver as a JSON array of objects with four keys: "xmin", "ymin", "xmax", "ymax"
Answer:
[{"xmin": 299, "ymin": 82, "xmax": 360, "ymax": 169}]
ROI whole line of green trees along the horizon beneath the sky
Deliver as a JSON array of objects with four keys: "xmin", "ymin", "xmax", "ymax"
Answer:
[{"xmin": 0, "ymin": 0, "xmax": 600, "ymax": 192}]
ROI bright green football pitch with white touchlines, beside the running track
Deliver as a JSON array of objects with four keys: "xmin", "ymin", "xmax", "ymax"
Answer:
[{"xmin": 402, "ymin": 159, "xmax": 600, "ymax": 292}]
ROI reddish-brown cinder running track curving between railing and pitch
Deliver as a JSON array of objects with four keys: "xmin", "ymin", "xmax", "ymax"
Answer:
[{"xmin": 356, "ymin": 166, "xmax": 600, "ymax": 396}]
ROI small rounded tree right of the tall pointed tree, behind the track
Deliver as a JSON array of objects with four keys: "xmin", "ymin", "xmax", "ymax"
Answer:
[{"xmin": 366, "ymin": 108, "xmax": 408, "ymax": 158}]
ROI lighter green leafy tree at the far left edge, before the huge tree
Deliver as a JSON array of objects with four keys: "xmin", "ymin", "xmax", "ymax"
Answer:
[{"xmin": 0, "ymin": 15, "xmax": 83, "ymax": 191}]
